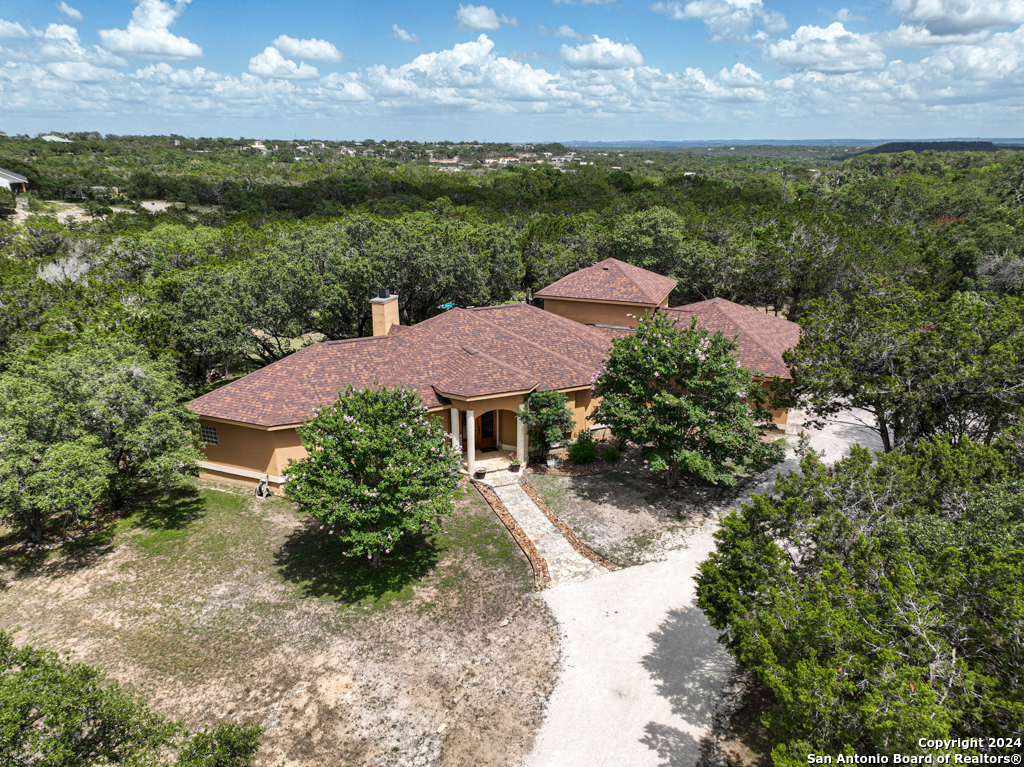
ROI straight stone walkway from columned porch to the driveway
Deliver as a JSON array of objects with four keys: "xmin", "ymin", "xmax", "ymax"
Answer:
[{"xmin": 484, "ymin": 471, "xmax": 608, "ymax": 586}]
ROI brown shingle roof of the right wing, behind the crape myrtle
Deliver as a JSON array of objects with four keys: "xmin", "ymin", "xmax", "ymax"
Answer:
[{"xmin": 668, "ymin": 298, "xmax": 800, "ymax": 378}]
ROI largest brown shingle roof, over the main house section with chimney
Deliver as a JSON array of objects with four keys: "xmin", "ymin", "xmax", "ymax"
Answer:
[{"xmin": 189, "ymin": 304, "xmax": 611, "ymax": 427}]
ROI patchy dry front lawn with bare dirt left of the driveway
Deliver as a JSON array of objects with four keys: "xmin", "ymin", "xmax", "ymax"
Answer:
[{"xmin": 0, "ymin": 482, "xmax": 558, "ymax": 767}]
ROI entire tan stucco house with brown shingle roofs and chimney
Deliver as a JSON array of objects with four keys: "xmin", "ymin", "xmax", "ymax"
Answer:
[{"xmin": 189, "ymin": 259, "xmax": 800, "ymax": 485}]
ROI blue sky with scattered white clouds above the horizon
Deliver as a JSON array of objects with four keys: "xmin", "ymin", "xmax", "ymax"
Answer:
[{"xmin": 0, "ymin": 0, "xmax": 1024, "ymax": 141}]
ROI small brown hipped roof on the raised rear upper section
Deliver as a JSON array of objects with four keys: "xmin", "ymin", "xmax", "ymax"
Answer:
[{"xmin": 537, "ymin": 258, "xmax": 677, "ymax": 306}]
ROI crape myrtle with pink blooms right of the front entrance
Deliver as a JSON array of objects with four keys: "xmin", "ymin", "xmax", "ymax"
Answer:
[{"xmin": 593, "ymin": 312, "xmax": 783, "ymax": 487}]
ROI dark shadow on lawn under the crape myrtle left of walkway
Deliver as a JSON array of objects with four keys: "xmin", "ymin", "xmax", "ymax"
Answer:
[{"xmin": 274, "ymin": 520, "xmax": 441, "ymax": 608}]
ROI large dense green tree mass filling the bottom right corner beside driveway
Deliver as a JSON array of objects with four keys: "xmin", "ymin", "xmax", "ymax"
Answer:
[{"xmin": 697, "ymin": 437, "xmax": 1024, "ymax": 767}]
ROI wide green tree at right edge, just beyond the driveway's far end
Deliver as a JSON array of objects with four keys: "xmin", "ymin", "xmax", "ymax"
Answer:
[{"xmin": 785, "ymin": 283, "xmax": 1024, "ymax": 452}]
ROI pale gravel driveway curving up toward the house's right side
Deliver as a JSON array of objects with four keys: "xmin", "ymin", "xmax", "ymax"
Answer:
[{"xmin": 526, "ymin": 413, "xmax": 879, "ymax": 767}]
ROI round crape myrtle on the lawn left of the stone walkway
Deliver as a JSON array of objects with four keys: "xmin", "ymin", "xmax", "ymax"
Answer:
[{"xmin": 285, "ymin": 386, "xmax": 459, "ymax": 568}]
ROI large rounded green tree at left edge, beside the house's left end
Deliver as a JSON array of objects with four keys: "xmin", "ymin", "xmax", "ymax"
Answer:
[{"xmin": 0, "ymin": 337, "xmax": 200, "ymax": 542}]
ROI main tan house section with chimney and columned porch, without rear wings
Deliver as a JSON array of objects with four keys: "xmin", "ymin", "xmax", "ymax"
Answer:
[{"xmin": 189, "ymin": 291, "xmax": 611, "ymax": 485}]
